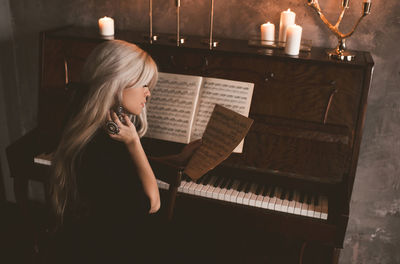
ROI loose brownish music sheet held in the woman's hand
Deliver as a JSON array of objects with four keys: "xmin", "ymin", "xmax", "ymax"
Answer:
[{"xmin": 184, "ymin": 105, "xmax": 253, "ymax": 180}]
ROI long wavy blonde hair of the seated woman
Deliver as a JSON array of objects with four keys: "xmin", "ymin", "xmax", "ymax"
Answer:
[{"xmin": 51, "ymin": 40, "xmax": 158, "ymax": 223}]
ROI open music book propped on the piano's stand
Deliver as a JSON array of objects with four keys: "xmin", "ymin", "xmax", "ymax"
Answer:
[{"xmin": 146, "ymin": 72, "xmax": 254, "ymax": 152}]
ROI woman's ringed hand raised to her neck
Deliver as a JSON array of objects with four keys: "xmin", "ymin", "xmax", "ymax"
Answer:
[{"xmin": 108, "ymin": 111, "xmax": 140, "ymax": 145}]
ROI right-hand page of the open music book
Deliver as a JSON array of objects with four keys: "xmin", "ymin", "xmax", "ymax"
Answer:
[{"xmin": 190, "ymin": 78, "xmax": 254, "ymax": 152}]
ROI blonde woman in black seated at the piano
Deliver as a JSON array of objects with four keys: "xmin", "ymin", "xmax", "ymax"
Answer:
[{"xmin": 52, "ymin": 40, "xmax": 199, "ymax": 263}]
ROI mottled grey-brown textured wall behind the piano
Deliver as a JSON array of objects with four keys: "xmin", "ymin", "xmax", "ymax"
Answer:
[{"xmin": 1, "ymin": 0, "xmax": 400, "ymax": 263}]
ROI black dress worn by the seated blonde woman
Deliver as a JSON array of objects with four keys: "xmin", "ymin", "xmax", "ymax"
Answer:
[{"xmin": 51, "ymin": 129, "xmax": 156, "ymax": 263}]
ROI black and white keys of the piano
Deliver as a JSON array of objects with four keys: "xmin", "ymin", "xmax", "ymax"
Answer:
[{"xmin": 157, "ymin": 174, "xmax": 329, "ymax": 220}]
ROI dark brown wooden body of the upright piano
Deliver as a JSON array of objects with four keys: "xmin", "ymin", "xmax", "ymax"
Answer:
[{"xmin": 7, "ymin": 27, "xmax": 373, "ymax": 262}]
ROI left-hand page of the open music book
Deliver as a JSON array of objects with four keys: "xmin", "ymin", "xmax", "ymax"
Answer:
[{"xmin": 146, "ymin": 72, "xmax": 202, "ymax": 143}]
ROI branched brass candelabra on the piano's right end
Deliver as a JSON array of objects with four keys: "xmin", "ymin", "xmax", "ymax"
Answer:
[{"xmin": 307, "ymin": 0, "xmax": 371, "ymax": 61}]
